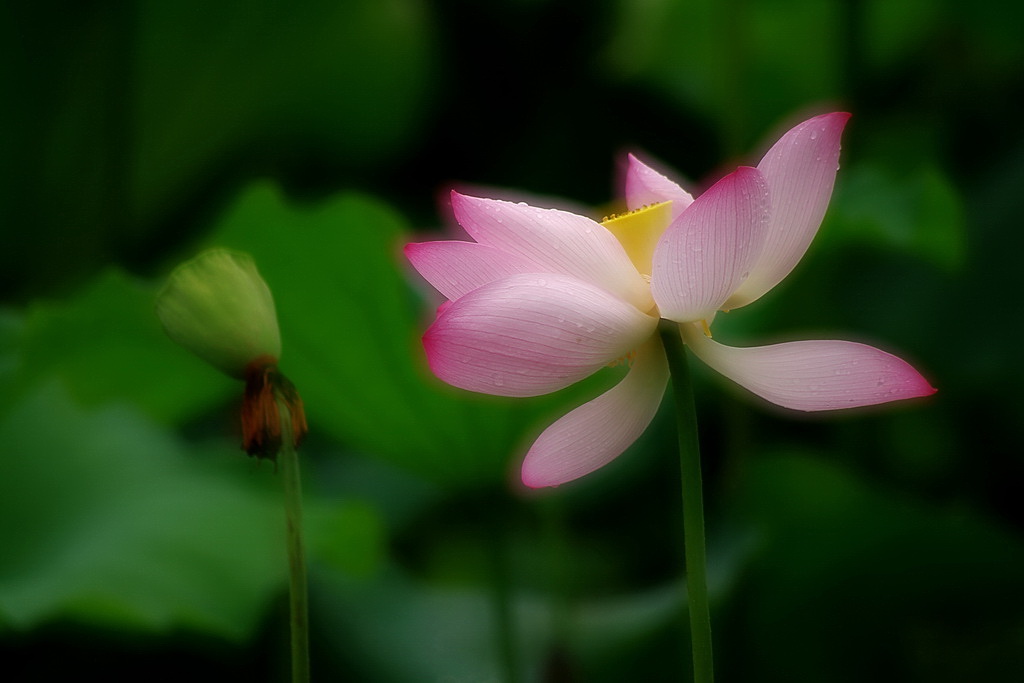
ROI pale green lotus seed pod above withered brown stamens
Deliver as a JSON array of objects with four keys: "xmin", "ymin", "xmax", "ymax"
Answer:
[{"xmin": 157, "ymin": 249, "xmax": 281, "ymax": 379}]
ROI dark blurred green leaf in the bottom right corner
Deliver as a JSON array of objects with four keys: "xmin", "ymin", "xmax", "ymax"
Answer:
[{"xmin": 731, "ymin": 455, "xmax": 1024, "ymax": 683}]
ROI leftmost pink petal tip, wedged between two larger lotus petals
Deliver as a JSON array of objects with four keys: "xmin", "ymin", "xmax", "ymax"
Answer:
[{"xmin": 404, "ymin": 241, "xmax": 544, "ymax": 299}]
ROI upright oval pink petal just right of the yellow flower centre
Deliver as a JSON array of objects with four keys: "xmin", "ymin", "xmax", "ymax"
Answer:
[{"xmin": 650, "ymin": 167, "xmax": 768, "ymax": 323}]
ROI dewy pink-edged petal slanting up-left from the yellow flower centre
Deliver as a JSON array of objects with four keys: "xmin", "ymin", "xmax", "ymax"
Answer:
[{"xmin": 452, "ymin": 193, "xmax": 653, "ymax": 310}]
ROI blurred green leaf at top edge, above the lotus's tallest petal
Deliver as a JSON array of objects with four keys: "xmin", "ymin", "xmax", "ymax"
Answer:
[{"xmin": 606, "ymin": 0, "xmax": 844, "ymax": 149}]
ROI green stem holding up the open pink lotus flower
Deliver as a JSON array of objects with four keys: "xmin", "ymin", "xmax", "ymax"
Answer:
[{"xmin": 659, "ymin": 322, "xmax": 715, "ymax": 683}]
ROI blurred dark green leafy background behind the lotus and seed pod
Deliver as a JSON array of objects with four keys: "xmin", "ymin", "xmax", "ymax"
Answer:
[{"xmin": 0, "ymin": 0, "xmax": 1024, "ymax": 683}]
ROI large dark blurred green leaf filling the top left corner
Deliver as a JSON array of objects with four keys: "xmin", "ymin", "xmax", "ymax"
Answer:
[{"xmin": 0, "ymin": 0, "xmax": 435, "ymax": 297}]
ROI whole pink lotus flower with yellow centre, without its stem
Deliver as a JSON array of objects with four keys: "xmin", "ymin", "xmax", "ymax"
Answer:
[{"xmin": 406, "ymin": 114, "xmax": 935, "ymax": 487}]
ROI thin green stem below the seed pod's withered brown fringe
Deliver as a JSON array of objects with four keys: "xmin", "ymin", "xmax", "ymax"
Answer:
[{"xmin": 276, "ymin": 397, "xmax": 309, "ymax": 683}]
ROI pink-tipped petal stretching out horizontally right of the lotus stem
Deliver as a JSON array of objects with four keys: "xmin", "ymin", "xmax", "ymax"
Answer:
[{"xmin": 680, "ymin": 325, "xmax": 935, "ymax": 411}]
